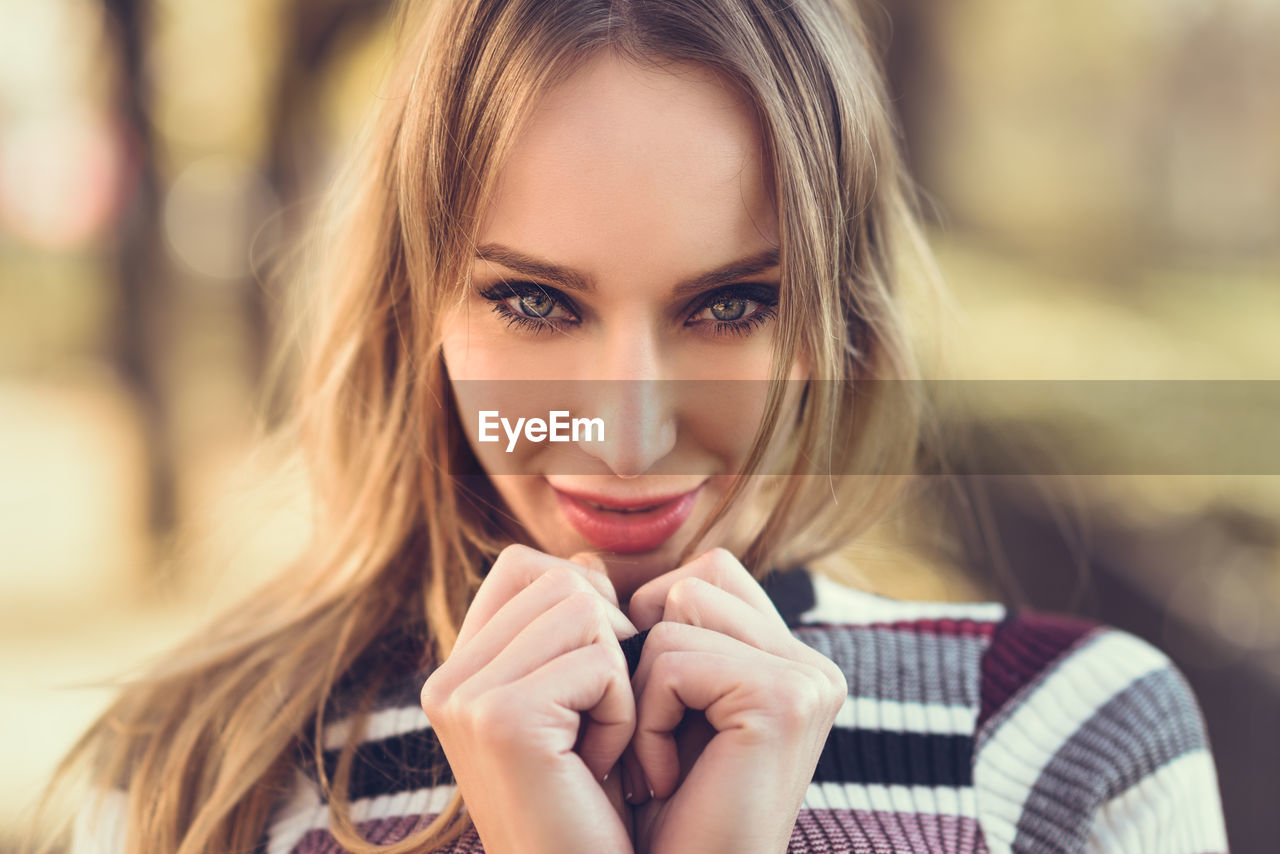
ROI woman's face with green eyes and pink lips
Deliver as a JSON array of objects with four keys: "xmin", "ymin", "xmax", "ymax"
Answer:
[{"xmin": 443, "ymin": 51, "xmax": 799, "ymax": 602}]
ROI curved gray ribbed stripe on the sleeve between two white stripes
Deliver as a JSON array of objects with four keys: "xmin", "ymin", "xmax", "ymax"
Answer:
[{"xmin": 1012, "ymin": 667, "xmax": 1207, "ymax": 851}]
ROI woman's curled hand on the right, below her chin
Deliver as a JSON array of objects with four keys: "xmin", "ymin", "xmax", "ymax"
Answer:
[{"xmin": 623, "ymin": 549, "xmax": 849, "ymax": 854}]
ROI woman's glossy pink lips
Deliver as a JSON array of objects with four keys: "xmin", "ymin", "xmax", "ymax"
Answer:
[{"xmin": 553, "ymin": 485, "xmax": 701, "ymax": 554}]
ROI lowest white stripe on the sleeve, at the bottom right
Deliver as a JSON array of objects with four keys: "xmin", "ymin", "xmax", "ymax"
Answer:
[{"xmin": 1084, "ymin": 750, "xmax": 1226, "ymax": 854}]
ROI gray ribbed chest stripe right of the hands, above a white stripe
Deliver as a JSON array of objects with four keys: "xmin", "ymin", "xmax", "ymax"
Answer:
[{"xmin": 791, "ymin": 626, "xmax": 989, "ymax": 708}]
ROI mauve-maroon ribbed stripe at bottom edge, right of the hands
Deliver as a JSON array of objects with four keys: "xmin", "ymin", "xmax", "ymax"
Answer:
[{"xmin": 787, "ymin": 809, "xmax": 987, "ymax": 854}]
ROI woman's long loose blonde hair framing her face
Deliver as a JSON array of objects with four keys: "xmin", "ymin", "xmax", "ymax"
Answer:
[{"xmin": 24, "ymin": 0, "xmax": 927, "ymax": 854}]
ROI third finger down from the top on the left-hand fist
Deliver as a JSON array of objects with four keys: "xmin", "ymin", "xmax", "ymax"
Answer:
[{"xmin": 457, "ymin": 590, "xmax": 630, "ymax": 702}]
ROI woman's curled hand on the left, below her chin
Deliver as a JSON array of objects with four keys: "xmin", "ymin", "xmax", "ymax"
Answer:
[{"xmin": 421, "ymin": 545, "xmax": 636, "ymax": 854}]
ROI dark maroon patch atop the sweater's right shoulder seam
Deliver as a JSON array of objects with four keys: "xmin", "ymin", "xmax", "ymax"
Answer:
[{"xmin": 977, "ymin": 611, "xmax": 1098, "ymax": 730}]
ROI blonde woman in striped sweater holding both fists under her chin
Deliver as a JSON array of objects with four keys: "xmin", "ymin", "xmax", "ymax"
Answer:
[{"xmin": 35, "ymin": 0, "xmax": 1226, "ymax": 854}]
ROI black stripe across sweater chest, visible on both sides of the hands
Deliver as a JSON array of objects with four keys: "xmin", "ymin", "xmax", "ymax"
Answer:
[{"xmin": 324, "ymin": 727, "xmax": 973, "ymax": 800}]
